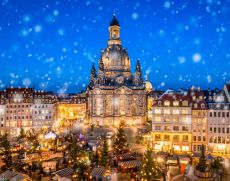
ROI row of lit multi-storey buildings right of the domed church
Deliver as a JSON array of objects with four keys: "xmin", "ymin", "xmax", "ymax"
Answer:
[{"xmin": 151, "ymin": 84, "xmax": 230, "ymax": 153}]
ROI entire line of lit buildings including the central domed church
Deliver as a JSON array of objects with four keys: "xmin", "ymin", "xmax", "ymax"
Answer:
[{"xmin": 0, "ymin": 17, "xmax": 230, "ymax": 153}]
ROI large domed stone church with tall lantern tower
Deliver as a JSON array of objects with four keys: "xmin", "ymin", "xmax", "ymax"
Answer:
[{"xmin": 87, "ymin": 17, "xmax": 147, "ymax": 126}]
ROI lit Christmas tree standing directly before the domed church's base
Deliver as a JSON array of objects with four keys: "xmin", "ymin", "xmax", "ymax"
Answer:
[{"xmin": 113, "ymin": 122, "xmax": 127, "ymax": 154}]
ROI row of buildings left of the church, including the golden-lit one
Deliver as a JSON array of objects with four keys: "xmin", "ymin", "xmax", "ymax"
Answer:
[{"xmin": 0, "ymin": 88, "xmax": 86, "ymax": 136}]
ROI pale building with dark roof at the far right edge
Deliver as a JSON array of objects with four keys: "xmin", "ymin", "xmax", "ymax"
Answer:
[{"xmin": 205, "ymin": 84, "xmax": 230, "ymax": 154}]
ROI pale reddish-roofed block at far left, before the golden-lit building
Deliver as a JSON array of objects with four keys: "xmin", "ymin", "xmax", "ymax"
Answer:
[{"xmin": 0, "ymin": 87, "xmax": 57, "ymax": 137}]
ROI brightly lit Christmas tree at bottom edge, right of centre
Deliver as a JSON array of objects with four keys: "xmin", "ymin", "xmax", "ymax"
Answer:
[{"xmin": 140, "ymin": 148, "xmax": 160, "ymax": 181}]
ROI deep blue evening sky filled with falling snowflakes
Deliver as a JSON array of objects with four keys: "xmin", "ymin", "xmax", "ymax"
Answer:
[{"xmin": 0, "ymin": 0, "xmax": 230, "ymax": 93}]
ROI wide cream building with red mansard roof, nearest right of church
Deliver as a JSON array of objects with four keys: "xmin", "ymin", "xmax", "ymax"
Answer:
[{"xmin": 151, "ymin": 90, "xmax": 192, "ymax": 152}]
